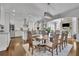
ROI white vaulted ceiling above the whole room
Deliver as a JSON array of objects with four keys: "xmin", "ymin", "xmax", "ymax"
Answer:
[{"xmin": 0, "ymin": 3, "xmax": 79, "ymax": 21}]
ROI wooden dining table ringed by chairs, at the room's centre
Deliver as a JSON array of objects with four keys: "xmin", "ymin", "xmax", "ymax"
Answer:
[{"xmin": 33, "ymin": 34, "xmax": 48, "ymax": 52}]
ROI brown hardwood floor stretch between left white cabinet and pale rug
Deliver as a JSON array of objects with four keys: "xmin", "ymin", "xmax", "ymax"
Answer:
[{"xmin": 0, "ymin": 37, "xmax": 26, "ymax": 56}]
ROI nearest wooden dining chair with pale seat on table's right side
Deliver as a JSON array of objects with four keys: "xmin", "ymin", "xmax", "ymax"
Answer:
[{"xmin": 46, "ymin": 34, "xmax": 59, "ymax": 56}]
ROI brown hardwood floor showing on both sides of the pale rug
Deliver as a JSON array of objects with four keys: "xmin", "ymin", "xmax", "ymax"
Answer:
[{"xmin": 0, "ymin": 37, "xmax": 77, "ymax": 56}]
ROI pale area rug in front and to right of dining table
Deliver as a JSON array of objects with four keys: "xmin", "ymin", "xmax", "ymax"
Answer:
[{"xmin": 33, "ymin": 44, "xmax": 73, "ymax": 56}]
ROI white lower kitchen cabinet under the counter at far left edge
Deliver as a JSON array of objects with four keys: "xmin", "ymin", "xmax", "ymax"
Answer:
[{"xmin": 0, "ymin": 32, "xmax": 10, "ymax": 51}]
